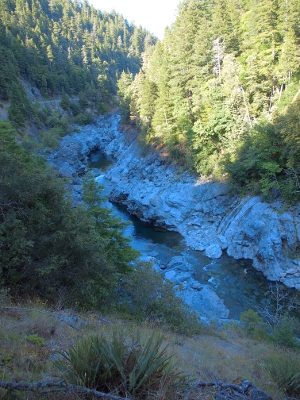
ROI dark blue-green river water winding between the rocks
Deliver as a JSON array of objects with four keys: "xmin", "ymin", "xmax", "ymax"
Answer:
[{"xmin": 90, "ymin": 151, "xmax": 269, "ymax": 319}]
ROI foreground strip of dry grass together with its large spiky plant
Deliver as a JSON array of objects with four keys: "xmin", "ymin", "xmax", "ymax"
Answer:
[{"xmin": 0, "ymin": 296, "xmax": 299, "ymax": 400}]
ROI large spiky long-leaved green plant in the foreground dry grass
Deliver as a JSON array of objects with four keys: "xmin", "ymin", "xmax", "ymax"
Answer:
[{"xmin": 57, "ymin": 330, "xmax": 187, "ymax": 399}]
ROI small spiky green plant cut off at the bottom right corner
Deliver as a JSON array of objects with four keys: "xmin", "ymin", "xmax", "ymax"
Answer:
[{"xmin": 265, "ymin": 354, "xmax": 300, "ymax": 397}]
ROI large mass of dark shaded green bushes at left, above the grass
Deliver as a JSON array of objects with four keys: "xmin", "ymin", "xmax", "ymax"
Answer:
[{"xmin": 0, "ymin": 121, "xmax": 136, "ymax": 309}]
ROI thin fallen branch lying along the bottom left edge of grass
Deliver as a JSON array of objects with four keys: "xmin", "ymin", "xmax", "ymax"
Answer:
[{"xmin": 0, "ymin": 380, "xmax": 131, "ymax": 400}]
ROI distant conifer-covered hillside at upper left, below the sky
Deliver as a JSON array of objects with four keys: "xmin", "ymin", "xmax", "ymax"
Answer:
[{"xmin": 0, "ymin": 0, "xmax": 156, "ymax": 125}]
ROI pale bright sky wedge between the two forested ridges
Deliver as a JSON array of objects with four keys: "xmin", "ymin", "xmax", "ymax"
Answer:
[{"xmin": 89, "ymin": 0, "xmax": 180, "ymax": 39}]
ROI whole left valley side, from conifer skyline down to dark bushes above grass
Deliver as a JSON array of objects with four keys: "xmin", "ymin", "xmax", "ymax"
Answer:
[{"xmin": 0, "ymin": 0, "xmax": 199, "ymax": 332}]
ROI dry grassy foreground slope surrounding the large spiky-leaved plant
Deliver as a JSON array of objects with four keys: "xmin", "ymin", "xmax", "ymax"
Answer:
[{"xmin": 0, "ymin": 298, "xmax": 299, "ymax": 400}]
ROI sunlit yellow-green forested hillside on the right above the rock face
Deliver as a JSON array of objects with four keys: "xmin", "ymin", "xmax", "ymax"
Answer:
[{"xmin": 119, "ymin": 0, "xmax": 300, "ymax": 202}]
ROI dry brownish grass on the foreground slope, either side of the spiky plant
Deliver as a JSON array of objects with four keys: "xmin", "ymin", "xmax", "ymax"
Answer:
[{"xmin": 0, "ymin": 304, "xmax": 296, "ymax": 400}]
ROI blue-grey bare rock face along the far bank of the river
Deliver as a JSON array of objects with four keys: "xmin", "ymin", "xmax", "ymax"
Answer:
[{"xmin": 53, "ymin": 114, "xmax": 300, "ymax": 290}]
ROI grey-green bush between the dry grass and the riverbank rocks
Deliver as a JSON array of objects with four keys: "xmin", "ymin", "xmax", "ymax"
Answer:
[{"xmin": 121, "ymin": 262, "xmax": 203, "ymax": 334}]
